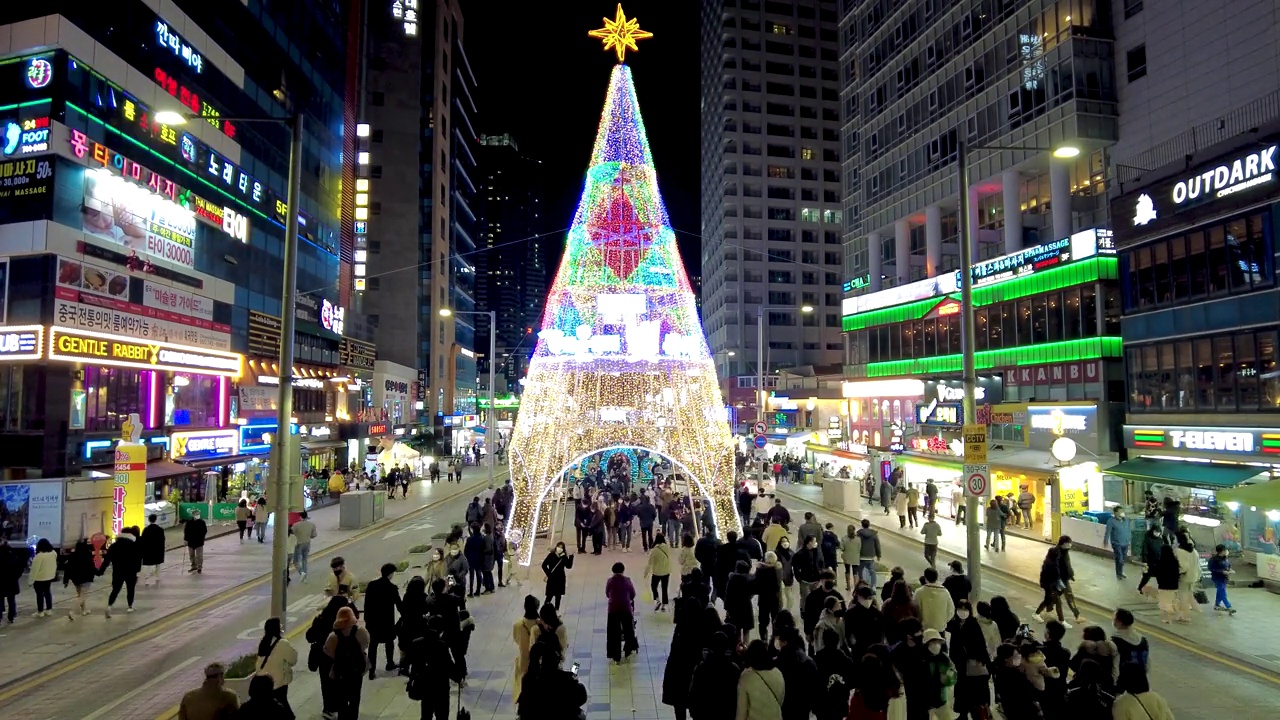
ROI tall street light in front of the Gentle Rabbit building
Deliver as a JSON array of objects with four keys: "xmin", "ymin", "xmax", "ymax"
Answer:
[{"xmin": 154, "ymin": 110, "xmax": 302, "ymax": 629}]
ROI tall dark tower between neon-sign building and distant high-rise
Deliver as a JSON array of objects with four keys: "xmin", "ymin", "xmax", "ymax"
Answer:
[{"xmin": 357, "ymin": 0, "xmax": 476, "ymax": 421}]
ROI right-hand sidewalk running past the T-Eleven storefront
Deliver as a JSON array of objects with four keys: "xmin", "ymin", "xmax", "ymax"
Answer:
[{"xmin": 778, "ymin": 484, "xmax": 1280, "ymax": 673}]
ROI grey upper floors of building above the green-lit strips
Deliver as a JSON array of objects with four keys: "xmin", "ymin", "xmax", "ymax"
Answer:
[{"xmin": 840, "ymin": 0, "xmax": 1117, "ymax": 297}]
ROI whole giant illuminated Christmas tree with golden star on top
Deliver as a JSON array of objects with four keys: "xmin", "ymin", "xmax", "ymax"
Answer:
[{"xmin": 509, "ymin": 6, "xmax": 740, "ymax": 565}]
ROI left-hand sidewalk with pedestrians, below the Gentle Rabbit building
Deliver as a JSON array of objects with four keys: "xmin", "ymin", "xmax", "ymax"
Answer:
[{"xmin": 0, "ymin": 469, "xmax": 488, "ymax": 688}]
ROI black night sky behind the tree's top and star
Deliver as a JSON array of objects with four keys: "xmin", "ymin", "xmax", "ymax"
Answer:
[{"xmin": 463, "ymin": 0, "xmax": 701, "ymax": 275}]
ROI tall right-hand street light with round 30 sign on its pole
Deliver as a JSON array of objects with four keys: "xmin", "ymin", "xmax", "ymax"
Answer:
[{"xmin": 956, "ymin": 140, "xmax": 1080, "ymax": 602}]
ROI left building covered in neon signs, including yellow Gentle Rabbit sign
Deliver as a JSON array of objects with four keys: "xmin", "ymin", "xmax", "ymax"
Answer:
[{"xmin": 0, "ymin": 0, "xmax": 375, "ymax": 486}]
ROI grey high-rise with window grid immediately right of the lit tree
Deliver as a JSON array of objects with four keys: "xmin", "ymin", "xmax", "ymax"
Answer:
[{"xmin": 701, "ymin": 0, "xmax": 844, "ymax": 377}]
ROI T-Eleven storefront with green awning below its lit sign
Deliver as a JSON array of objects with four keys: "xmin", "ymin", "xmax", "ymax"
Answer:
[{"xmin": 1103, "ymin": 425, "xmax": 1280, "ymax": 553}]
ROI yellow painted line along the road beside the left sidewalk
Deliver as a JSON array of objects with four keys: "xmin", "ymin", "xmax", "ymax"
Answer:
[{"xmin": 0, "ymin": 478, "xmax": 486, "ymax": 702}]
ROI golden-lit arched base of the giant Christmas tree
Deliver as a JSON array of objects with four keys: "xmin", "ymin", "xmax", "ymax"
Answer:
[{"xmin": 508, "ymin": 357, "xmax": 741, "ymax": 565}]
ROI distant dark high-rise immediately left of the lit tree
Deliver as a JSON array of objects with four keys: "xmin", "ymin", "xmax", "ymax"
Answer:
[{"xmin": 476, "ymin": 133, "xmax": 550, "ymax": 393}]
